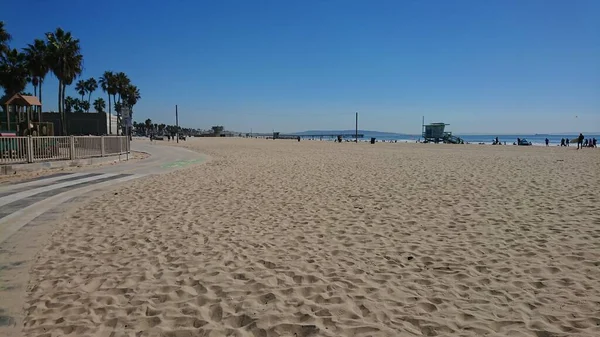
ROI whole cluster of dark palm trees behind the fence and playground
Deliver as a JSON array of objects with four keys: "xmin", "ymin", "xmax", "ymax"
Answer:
[{"xmin": 0, "ymin": 21, "xmax": 141, "ymax": 134}]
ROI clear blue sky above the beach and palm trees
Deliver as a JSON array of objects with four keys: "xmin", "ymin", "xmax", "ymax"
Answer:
[{"xmin": 0, "ymin": 0, "xmax": 600, "ymax": 134}]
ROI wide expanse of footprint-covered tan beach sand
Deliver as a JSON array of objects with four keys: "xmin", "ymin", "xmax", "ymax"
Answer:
[{"xmin": 14, "ymin": 138, "xmax": 600, "ymax": 337}]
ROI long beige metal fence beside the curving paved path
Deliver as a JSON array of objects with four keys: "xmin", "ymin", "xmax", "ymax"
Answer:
[{"xmin": 0, "ymin": 136, "xmax": 129, "ymax": 165}]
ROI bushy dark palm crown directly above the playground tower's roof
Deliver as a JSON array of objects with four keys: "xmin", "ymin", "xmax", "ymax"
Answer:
[{"xmin": 0, "ymin": 49, "xmax": 29, "ymax": 97}]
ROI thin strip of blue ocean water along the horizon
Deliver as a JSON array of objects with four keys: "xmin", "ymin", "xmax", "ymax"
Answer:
[{"xmin": 363, "ymin": 133, "xmax": 600, "ymax": 146}]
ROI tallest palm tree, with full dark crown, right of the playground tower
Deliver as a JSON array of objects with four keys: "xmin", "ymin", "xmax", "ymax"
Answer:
[{"xmin": 46, "ymin": 28, "xmax": 83, "ymax": 134}]
